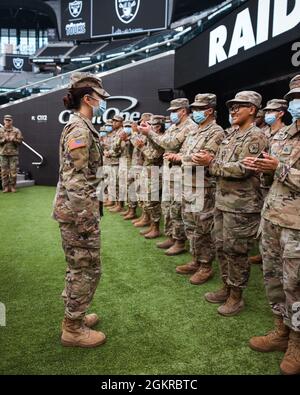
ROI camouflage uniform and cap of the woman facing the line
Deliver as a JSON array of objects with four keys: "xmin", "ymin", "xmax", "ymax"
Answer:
[{"xmin": 53, "ymin": 73, "xmax": 108, "ymax": 322}]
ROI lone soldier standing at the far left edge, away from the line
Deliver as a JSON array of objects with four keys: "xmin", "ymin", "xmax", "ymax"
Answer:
[{"xmin": 0, "ymin": 115, "xmax": 23, "ymax": 193}]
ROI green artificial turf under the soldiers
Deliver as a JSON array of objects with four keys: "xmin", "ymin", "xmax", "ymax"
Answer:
[{"xmin": 0, "ymin": 186, "xmax": 283, "ymax": 375}]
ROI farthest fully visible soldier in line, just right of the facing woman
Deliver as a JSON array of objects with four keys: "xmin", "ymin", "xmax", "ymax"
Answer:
[{"xmin": 104, "ymin": 115, "xmax": 124, "ymax": 213}]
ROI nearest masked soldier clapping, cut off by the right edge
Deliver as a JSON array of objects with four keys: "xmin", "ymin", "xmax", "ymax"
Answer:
[{"xmin": 244, "ymin": 75, "xmax": 300, "ymax": 375}]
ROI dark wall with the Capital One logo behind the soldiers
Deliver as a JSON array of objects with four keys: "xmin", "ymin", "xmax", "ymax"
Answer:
[{"xmin": 0, "ymin": 53, "xmax": 174, "ymax": 185}]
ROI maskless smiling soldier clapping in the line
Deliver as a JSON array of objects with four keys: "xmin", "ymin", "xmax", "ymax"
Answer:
[{"xmin": 194, "ymin": 91, "xmax": 267, "ymax": 317}]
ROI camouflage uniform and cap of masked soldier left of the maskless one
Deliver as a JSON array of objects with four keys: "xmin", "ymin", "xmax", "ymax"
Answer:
[{"xmin": 179, "ymin": 94, "xmax": 224, "ymax": 266}]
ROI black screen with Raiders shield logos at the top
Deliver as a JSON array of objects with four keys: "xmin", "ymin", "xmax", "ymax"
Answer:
[{"xmin": 61, "ymin": 0, "xmax": 168, "ymax": 40}]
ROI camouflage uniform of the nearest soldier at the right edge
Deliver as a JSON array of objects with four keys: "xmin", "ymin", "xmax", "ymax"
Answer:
[{"xmin": 262, "ymin": 123, "xmax": 300, "ymax": 332}]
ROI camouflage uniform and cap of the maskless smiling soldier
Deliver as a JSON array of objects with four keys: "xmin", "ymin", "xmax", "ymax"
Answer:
[{"xmin": 210, "ymin": 92, "xmax": 266, "ymax": 289}]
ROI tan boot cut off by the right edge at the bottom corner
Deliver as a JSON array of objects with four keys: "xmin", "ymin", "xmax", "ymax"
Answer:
[{"xmin": 280, "ymin": 330, "xmax": 300, "ymax": 375}]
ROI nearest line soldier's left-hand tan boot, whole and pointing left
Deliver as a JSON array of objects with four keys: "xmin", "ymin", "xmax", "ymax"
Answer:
[{"xmin": 249, "ymin": 317, "xmax": 290, "ymax": 352}]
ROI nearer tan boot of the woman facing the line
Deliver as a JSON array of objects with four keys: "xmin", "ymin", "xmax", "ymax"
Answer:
[{"xmin": 61, "ymin": 318, "xmax": 106, "ymax": 348}]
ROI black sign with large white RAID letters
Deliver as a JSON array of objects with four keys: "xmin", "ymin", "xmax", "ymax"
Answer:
[{"xmin": 175, "ymin": 0, "xmax": 300, "ymax": 86}]
